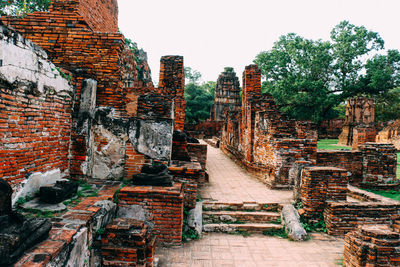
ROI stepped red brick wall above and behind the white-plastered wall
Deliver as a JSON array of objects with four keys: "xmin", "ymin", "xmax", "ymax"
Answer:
[{"xmin": 1, "ymin": 11, "xmax": 125, "ymax": 117}]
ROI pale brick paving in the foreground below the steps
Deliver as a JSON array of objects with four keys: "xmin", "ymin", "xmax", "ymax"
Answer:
[{"xmin": 156, "ymin": 233, "xmax": 344, "ymax": 267}]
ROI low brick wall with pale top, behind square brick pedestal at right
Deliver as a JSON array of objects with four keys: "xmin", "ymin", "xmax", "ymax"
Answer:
[{"xmin": 317, "ymin": 150, "xmax": 363, "ymax": 184}]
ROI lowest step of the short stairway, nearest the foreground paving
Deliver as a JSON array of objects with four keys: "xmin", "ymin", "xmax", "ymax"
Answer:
[{"xmin": 203, "ymin": 223, "xmax": 283, "ymax": 234}]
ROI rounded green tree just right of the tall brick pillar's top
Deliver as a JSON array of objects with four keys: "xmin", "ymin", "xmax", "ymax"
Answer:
[{"xmin": 255, "ymin": 33, "xmax": 337, "ymax": 121}]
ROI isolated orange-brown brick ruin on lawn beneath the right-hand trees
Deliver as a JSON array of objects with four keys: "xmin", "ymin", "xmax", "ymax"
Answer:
[{"xmin": 338, "ymin": 97, "xmax": 376, "ymax": 149}]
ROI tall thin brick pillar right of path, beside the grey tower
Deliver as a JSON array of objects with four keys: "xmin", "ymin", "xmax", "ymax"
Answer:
[{"xmin": 241, "ymin": 65, "xmax": 261, "ymax": 162}]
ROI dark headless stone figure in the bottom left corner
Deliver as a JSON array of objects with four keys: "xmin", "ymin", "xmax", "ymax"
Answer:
[{"xmin": 0, "ymin": 178, "xmax": 51, "ymax": 266}]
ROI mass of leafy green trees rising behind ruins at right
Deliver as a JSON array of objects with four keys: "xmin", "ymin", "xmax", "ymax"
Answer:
[{"xmin": 254, "ymin": 21, "xmax": 400, "ymax": 123}]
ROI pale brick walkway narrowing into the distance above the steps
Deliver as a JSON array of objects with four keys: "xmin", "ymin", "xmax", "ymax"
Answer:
[{"xmin": 201, "ymin": 146, "xmax": 293, "ymax": 203}]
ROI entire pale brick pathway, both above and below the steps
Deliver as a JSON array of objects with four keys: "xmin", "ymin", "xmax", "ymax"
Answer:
[{"xmin": 156, "ymin": 146, "xmax": 344, "ymax": 267}]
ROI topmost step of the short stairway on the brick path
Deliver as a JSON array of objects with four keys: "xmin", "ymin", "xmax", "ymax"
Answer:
[{"xmin": 203, "ymin": 201, "xmax": 282, "ymax": 211}]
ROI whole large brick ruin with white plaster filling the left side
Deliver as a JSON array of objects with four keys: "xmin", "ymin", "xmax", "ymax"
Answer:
[{"xmin": 0, "ymin": 0, "xmax": 207, "ymax": 266}]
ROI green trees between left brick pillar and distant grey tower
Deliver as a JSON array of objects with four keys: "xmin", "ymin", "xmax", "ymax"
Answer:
[{"xmin": 185, "ymin": 67, "xmax": 216, "ymax": 123}]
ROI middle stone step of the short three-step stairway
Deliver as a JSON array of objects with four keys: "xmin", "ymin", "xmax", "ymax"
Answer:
[{"xmin": 203, "ymin": 210, "xmax": 281, "ymax": 224}]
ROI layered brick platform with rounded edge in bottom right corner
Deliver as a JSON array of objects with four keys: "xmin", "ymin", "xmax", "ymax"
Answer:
[{"xmin": 343, "ymin": 225, "xmax": 400, "ymax": 267}]
